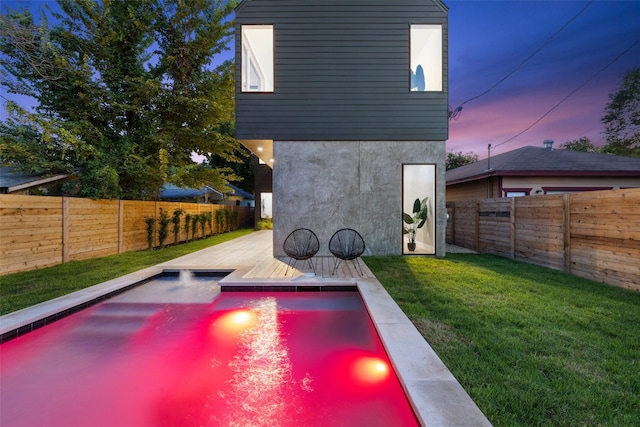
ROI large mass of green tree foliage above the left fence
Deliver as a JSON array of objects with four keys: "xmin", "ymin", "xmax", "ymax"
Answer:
[{"xmin": 0, "ymin": 0, "xmax": 242, "ymax": 199}]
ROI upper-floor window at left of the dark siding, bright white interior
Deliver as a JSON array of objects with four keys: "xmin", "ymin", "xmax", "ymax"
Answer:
[{"xmin": 242, "ymin": 25, "xmax": 273, "ymax": 92}]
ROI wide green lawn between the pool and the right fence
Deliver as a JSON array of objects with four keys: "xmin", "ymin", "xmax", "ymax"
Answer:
[{"xmin": 365, "ymin": 254, "xmax": 640, "ymax": 426}]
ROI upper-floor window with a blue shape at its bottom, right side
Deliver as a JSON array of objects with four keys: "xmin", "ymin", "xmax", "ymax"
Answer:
[{"xmin": 409, "ymin": 24, "xmax": 442, "ymax": 91}]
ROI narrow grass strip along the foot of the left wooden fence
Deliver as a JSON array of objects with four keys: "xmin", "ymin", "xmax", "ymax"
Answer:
[{"xmin": 0, "ymin": 229, "xmax": 253, "ymax": 315}]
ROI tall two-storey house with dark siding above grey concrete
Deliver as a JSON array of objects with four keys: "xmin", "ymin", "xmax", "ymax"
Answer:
[{"xmin": 236, "ymin": 0, "xmax": 449, "ymax": 256}]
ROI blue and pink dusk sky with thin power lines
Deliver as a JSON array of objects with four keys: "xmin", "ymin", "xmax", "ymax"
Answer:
[{"xmin": 0, "ymin": 0, "xmax": 640, "ymax": 158}]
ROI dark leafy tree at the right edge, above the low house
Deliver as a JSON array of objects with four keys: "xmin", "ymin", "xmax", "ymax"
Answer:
[{"xmin": 602, "ymin": 67, "xmax": 640, "ymax": 157}]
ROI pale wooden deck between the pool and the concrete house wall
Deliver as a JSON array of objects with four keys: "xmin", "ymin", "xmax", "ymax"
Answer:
[{"xmin": 162, "ymin": 230, "xmax": 374, "ymax": 281}]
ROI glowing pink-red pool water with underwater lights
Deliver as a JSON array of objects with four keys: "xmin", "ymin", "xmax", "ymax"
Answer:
[{"xmin": 0, "ymin": 278, "xmax": 418, "ymax": 427}]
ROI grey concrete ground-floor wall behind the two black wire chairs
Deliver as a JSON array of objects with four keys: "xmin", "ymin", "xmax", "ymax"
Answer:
[{"xmin": 273, "ymin": 141, "xmax": 446, "ymax": 256}]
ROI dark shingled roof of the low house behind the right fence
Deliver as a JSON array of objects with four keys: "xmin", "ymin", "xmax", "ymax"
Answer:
[{"xmin": 446, "ymin": 146, "xmax": 640, "ymax": 184}]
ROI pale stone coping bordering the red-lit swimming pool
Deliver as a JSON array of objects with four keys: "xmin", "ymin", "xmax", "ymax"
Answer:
[{"xmin": 0, "ymin": 265, "xmax": 491, "ymax": 427}]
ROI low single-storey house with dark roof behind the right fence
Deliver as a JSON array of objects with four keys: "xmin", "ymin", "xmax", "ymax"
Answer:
[{"xmin": 447, "ymin": 141, "xmax": 640, "ymax": 202}]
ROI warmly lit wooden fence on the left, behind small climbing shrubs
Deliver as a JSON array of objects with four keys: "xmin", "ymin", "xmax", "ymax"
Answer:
[{"xmin": 0, "ymin": 195, "xmax": 253, "ymax": 275}]
